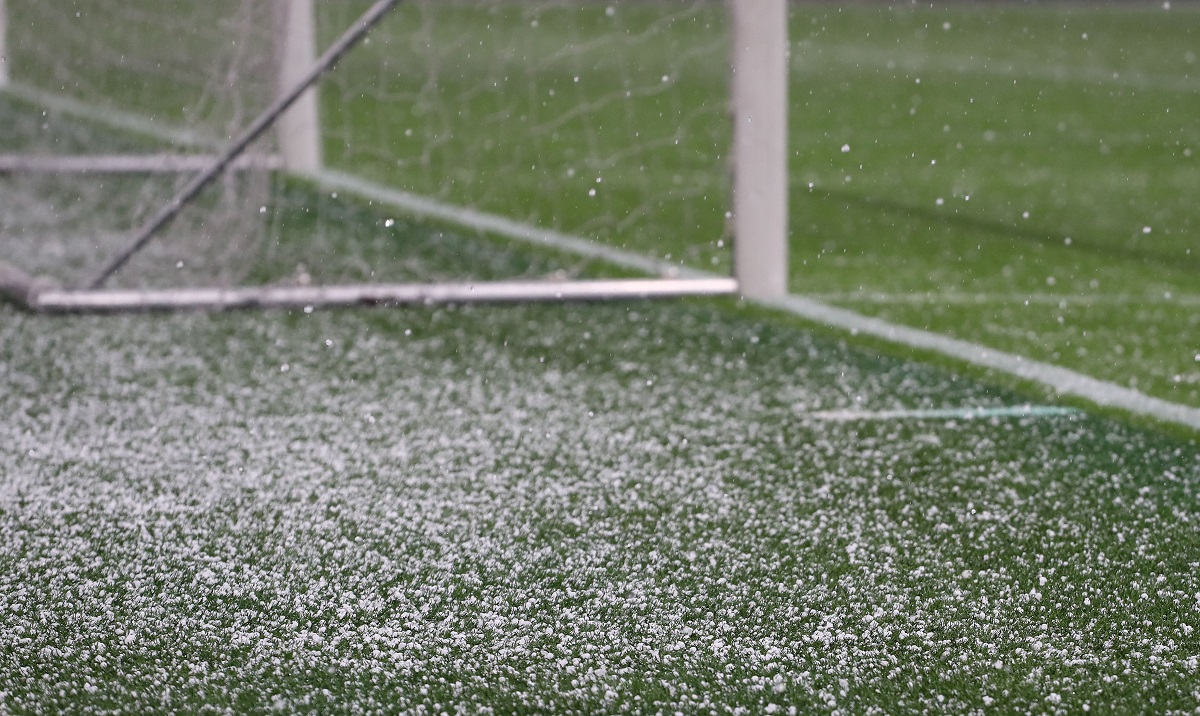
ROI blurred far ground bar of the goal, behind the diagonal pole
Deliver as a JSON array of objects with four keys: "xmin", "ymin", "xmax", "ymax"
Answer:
[{"xmin": 0, "ymin": 154, "xmax": 282, "ymax": 174}]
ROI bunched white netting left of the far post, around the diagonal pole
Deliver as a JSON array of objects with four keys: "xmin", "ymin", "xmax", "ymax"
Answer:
[{"xmin": 2, "ymin": 0, "xmax": 277, "ymax": 285}]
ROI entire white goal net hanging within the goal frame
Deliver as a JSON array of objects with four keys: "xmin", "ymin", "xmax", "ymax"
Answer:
[{"xmin": 0, "ymin": 0, "xmax": 730, "ymax": 287}]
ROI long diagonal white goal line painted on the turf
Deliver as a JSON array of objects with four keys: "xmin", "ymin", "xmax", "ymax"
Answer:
[{"xmin": 10, "ymin": 85, "xmax": 1200, "ymax": 429}]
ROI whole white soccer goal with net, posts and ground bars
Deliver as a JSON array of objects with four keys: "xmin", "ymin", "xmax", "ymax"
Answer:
[{"xmin": 0, "ymin": 0, "xmax": 786, "ymax": 312}]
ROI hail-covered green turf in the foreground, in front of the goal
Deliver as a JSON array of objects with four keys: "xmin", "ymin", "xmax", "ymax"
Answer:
[{"xmin": 0, "ymin": 298, "xmax": 1200, "ymax": 714}]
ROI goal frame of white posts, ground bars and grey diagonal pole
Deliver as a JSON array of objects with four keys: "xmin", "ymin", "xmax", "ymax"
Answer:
[{"xmin": 0, "ymin": 0, "xmax": 787, "ymax": 312}]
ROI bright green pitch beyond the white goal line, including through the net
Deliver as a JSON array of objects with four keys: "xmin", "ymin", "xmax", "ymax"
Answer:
[{"xmin": 4, "ymin": 0, "xmax": 1200, "ymax": 407}]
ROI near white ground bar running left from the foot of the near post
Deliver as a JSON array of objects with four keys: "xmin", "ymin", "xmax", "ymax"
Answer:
[{"xmin": 28, "ymin": 278, "xmax": 738, "ymax": 313}]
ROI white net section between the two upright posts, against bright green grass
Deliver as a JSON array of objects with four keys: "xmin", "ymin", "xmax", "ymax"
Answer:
[{"xmin": 320, "ymin": 0, "xmax": 730, "ymax": 258}]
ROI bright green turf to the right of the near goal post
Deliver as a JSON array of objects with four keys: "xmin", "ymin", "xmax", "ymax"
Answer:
[{"xmin": 792, "ymin": 4, "xmax": 1200, "ymax": 405}]
